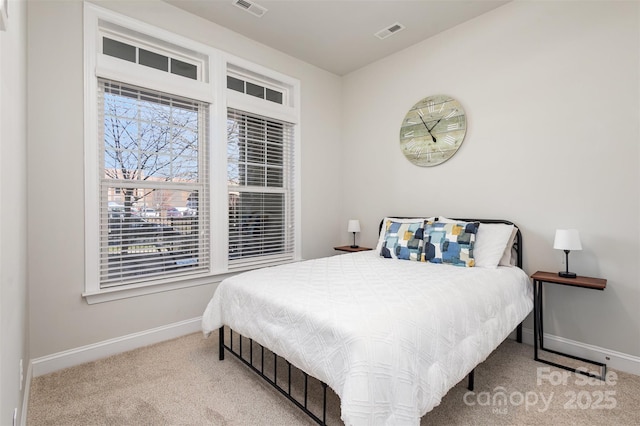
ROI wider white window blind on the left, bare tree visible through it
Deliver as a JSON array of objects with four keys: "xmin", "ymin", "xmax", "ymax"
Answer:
[{"xmin": 98, "ymin": 79, "xmax": 210, "ymax": 288}]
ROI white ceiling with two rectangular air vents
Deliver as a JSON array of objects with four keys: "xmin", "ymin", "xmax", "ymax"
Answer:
[{"xmin": 165, "ymin": 0, "xmax": 510, "ymax": 75}]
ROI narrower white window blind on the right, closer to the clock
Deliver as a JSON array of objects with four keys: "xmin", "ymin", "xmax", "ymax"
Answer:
[{"xmin": 227, "ymin": 108, "xmax": 294, "ymax": 270}]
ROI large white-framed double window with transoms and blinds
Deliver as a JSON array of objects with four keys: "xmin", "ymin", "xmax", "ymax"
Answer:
[{"xmin": 84, "ymin": 4, "xmax": 300, "ymax": 303}]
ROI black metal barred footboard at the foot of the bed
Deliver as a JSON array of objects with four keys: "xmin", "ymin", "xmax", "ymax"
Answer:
[{"xmin": 218, "ymin": 326, "xmax": 327, "ymax": 425}]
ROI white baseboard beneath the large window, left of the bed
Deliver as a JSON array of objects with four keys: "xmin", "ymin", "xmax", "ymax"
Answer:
[{"xmin": 27, "ymin": 317, "xmax": 202, "ymax": 383}]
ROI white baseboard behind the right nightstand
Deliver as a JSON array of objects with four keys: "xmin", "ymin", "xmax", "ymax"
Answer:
[{"xmin": 514, "ymin": 328, "xmax": 640, "ymax": 376}]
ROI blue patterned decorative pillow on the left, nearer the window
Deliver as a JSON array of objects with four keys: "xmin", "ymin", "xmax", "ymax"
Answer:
[{"xmin": 380, "ymin": 220, "xmax": 425, "ymax": 261}]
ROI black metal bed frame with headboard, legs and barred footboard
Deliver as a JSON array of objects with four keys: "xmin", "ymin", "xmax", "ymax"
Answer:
[{"xmin": 218, "ymin": 216, "xmax": 522, "ymax": 425}]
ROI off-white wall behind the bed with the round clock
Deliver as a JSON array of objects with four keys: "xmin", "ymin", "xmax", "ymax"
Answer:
[{"xmin": 342, "ymin": 1, "xmax": 640, "ymax": 357}]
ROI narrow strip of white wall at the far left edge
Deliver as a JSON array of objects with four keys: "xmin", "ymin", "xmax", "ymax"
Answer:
[{"xmin": 0, "ymin": 1, "xmax": 30, "ymax": 425}]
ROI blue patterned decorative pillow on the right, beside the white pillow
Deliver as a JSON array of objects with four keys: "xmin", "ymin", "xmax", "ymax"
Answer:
[{"xmin": 422, "ymin": 221, "xmax": 480, "ymax": 267}]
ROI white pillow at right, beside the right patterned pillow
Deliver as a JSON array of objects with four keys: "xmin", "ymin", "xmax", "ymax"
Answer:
[{"xmin": 473, "ymin": 223, "xmax": 515, "ymax": 269}]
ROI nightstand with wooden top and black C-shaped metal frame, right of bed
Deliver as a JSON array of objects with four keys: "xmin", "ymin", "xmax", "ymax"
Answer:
[{"xmin": 531, "ymin": 271, "xmax": 607, "ymax": 380}]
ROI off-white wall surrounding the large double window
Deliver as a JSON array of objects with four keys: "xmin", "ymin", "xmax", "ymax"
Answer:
[{"xmin": 25, "ymin": 1, "xmax": 341, "ymax": 360}]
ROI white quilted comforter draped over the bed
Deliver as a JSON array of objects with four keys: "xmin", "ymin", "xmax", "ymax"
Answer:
[{"xmin": 202, "ymin": 252, "xmax": 532, "ymax": 425}]
